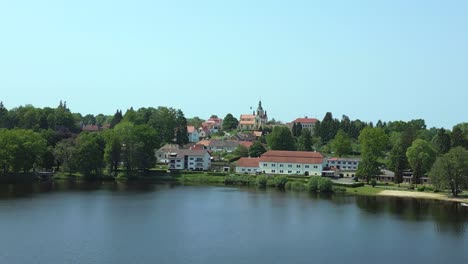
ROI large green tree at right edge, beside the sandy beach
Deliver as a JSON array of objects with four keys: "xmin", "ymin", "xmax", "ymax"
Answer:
[{"xmin": 429, "ymin": 147, "xmax": 468, "ymax": 197}]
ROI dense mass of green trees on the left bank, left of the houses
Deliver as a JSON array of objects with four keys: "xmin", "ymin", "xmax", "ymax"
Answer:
[{"xmin": 0, "ymin": 102, "xmax": 188, "ymax": 177}]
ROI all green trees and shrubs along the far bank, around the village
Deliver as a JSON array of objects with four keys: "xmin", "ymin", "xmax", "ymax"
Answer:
[{"xmin": 0, "ymin": 102, "xmax": 468, "ymax": 197}]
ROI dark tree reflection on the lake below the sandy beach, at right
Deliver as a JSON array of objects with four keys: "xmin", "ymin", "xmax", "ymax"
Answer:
[{"xmin": 356, "ymin": 196, "xmax": 468, "ymax": 236}]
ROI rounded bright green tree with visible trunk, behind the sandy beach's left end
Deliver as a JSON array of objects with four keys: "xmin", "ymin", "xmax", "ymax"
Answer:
[{"xmin": 406, "ymin": 139, "xmax": 436, "ymax": 184}]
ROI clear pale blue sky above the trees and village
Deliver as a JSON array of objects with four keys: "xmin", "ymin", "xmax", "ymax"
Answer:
[{"xmin": 0, "ymin": 0, "xmax": 468, "ymax": 128}]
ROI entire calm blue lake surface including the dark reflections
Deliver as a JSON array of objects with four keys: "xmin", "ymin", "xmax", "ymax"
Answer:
[{"xmin": 0, "ymin": 182, "xmax": 468, "ymax": 264}]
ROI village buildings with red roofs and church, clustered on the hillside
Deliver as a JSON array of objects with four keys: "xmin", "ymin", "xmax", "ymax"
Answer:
[{"xmin": 156, "ymin": 101, "xmax": 420, "ymax": 183}]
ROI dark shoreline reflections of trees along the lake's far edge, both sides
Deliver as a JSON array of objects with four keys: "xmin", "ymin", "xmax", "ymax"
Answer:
[{"xmin": 0, "ymin": 181, "xmax": 468, "ymax": 237}]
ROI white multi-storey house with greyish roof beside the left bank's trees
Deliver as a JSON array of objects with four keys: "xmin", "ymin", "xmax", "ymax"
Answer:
[{"xmin": 169, "ymin": 149, "xmax": 211, "ymax": 171}]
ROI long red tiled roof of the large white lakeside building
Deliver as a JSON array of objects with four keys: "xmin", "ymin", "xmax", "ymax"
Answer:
[{"xmin": 260, "ymin": 150, "xmax": 324, "ymax": 164}]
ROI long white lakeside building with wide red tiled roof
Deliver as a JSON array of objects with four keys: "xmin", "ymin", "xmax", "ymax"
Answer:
[{"xmin": 260, "ymin": 150, "xmax": 326, "ymax": 176}]
